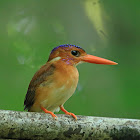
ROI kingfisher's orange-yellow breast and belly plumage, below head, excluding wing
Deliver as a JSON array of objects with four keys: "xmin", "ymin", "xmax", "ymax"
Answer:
[{"xmin": 25, "ymin": 61, "xmax": 79, "ymax": 112}]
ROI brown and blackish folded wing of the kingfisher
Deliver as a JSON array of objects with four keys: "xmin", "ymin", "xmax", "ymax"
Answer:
[{"xmin": 24, "ymin": 64, "xmax": 55, "ymax": 111}]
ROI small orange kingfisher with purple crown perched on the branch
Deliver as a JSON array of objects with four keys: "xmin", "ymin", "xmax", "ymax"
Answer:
[{"xmin": 24, "ymin": 44, "xmax": 117, "ymax": 120}]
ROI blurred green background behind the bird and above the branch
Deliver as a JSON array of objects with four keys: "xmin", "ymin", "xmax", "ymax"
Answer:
[{"xmin": 0, "ymin": 0, "xmax": 140, "ymax": 119}]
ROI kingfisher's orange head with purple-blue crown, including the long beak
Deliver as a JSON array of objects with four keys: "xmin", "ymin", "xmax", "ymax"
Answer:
[{"xmin": 48, "ymin": 45, "xmax": 117, "ymax": 66}]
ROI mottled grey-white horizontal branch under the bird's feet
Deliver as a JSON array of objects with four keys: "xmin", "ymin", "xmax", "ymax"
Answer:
[{"xmin": 0, "ymin": 110, "xmax": 140, "ymax": 140}]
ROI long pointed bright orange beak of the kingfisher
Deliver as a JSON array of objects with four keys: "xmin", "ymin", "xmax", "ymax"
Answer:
[{"xmin": 82, "ymin": 54, "xmax": 118, "ymax": 65}]
